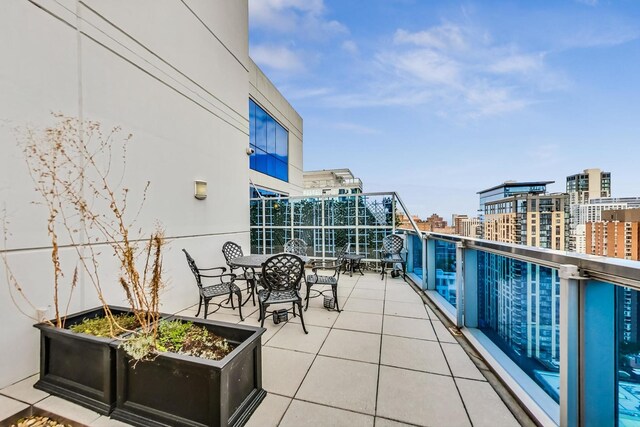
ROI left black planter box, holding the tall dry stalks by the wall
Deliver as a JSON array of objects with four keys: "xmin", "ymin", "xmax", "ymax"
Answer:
[{"xmin": 34, "ymin": 306, "xmax": 131, "ymax": 415}]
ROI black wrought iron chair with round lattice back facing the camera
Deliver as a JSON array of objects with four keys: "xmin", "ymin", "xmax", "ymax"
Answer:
[{"xmin": 258, "ymin": 254, "xmax": 308, "ymax": 334}]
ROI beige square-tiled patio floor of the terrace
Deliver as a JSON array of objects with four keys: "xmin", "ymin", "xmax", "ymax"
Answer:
[{"xmin": 0, "ymin": 274, "xmax": 520, "ymax": 427}]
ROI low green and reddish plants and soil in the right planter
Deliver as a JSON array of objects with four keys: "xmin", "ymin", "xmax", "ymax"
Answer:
[{"xmin": 156, "ymin": 320, "xmax": 234, "ymax": 360}]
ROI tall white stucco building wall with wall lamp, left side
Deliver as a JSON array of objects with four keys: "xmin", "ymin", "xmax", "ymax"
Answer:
[{"xmin": 0, "ymin": 0, "xmax": 302, "ymax": 388}]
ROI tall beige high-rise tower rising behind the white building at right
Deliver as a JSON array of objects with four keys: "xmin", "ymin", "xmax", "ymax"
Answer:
[{"xmin": 566, "ymin": 168, "xmax": 611, "ymax": 253}]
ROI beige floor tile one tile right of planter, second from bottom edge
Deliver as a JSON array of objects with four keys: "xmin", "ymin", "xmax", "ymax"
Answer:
[{"xmin": 296, "ymin": 356, "xmax": 378, "ymax": 415}]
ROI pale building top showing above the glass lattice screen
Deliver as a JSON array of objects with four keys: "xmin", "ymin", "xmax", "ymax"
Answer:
[{"xmin": 302, "ymin": 169, "xmax": 363, "ymax": 196}]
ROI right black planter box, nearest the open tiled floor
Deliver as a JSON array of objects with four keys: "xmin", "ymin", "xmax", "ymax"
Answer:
[{"xmin": 111, "ymin": 316, "xmax": 267, "ymax": 427}]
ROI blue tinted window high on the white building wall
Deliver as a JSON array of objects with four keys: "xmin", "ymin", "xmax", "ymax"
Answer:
[{"xmin": 249, "ymin": 99, "xmax": 289, "ymax": 181}]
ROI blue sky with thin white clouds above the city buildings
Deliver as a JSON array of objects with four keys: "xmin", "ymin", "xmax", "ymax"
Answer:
[{"xmin": 249, "ymin": 0, "xmax": 640, "ymax": 221}]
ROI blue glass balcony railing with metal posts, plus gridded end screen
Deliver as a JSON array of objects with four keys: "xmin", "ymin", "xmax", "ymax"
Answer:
[{"xmin": 251, "ymin": 193, "xmax": 640, "ymax": 426}]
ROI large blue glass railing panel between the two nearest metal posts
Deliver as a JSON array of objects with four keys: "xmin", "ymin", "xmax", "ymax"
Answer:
[{"xmin": 477, "ymin": 251, "xmax": 561, "ymax": 419}]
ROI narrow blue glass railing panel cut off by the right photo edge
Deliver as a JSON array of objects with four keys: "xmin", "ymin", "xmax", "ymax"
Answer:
[{"xmin": 616, "ymin": 286, "xmax": 640, "ymax": 427}]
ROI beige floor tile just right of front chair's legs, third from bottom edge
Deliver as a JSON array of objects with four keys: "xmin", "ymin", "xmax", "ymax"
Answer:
[{"xmin": 318, "ymin": 329, "xmax": 380, "ymax": 364}]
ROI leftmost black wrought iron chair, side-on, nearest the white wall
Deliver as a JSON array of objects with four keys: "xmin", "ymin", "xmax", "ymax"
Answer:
[{"xmin": 182, "ymin": 249, "xmax": 244, "ymax": 320}]
